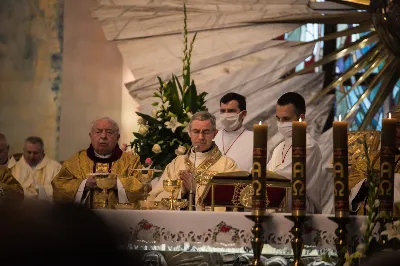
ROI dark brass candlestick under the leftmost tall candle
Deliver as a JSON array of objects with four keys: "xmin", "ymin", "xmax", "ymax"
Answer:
[{"xmin": 246, "ymin": 215, "xmax": 271, "ymax": 266}]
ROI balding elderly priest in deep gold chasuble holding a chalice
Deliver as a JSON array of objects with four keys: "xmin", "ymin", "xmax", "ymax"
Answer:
[{"xmin": 52, "ymin": 117, "xmax": 142, "ymax": 208}]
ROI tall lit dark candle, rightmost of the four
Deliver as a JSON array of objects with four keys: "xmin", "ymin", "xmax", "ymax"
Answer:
[{"xmin": 379, "ymin": 113, "xmax": 397, "ymax": 214}]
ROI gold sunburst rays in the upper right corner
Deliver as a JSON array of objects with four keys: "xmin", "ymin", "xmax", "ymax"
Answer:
[{"xmin": 248, "ymin": 0, "xmax": 400, "ymax": 130}]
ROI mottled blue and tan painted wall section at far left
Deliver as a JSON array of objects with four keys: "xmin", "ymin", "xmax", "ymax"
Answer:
[{"xmin": 0, "ymin": 0, "xmax": 63, "ymax": 157}]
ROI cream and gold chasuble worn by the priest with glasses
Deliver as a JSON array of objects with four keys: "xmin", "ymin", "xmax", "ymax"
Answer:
[{"xmin": 149, "ymin": 145, "xmax": 239, "ymax": 207}]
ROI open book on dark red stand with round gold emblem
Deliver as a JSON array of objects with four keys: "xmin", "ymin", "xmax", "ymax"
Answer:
[{"xmin": 199, "ymin": 171, "xmax": 291, "ymax": 209}]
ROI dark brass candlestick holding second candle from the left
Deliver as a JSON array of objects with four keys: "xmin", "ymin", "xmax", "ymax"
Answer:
[{"xmin": 285, "ymin": 215, "xmax": 309, "ymax": 266}]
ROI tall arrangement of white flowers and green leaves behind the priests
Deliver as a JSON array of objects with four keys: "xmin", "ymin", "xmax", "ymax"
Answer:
[{"xmin": 131, "ymin": 5, "xmax": 207, "ymax": 169}]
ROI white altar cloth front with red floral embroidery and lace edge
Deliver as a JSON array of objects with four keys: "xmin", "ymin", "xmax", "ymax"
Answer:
[{"xmin": 96, "ymin": 210, "xmax": 365, "ymax": 256}]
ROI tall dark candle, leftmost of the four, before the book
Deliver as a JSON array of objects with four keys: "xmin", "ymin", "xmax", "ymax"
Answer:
[{"xmin": 252, "ymin": 122, "xmax": 268, "ymax": 215}]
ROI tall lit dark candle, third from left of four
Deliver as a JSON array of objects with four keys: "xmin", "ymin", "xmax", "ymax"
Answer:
[{"xmin": 333, "ymin": 116, "xmax": 349, "ymax": 217}]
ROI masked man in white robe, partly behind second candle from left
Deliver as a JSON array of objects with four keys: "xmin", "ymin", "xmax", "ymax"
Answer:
[{"xmin": 267, "ymin": 92, "xmax": 323, "ymax": 213}]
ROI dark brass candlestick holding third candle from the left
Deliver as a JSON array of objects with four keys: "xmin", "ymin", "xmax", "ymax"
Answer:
[{"xmin": 329, "ymin": 216, "xmax": 351, "ymax": 266}]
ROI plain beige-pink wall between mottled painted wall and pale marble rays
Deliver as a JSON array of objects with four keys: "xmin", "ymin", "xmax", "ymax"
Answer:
[{"xmin": 59, "ymin": 0, "xmax": 125, "ymax": 160}]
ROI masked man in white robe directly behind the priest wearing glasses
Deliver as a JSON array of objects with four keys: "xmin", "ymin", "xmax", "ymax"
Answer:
[{"xmin": 214, "ymin": 92, "xmax": 270, "ymax": 172}]
